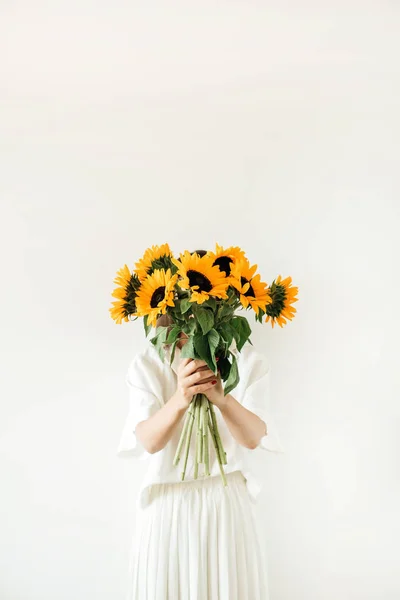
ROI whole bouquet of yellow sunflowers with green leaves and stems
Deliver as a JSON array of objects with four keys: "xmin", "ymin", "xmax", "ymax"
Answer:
[{"xmin": 109, "ymin": 244, "xmax": 298, "ymax": 485}]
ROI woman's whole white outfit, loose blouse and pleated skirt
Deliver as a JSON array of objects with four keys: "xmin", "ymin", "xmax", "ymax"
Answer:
[{"xmin": 117, "ymin": 341, "xmax": 284, "ymax": 600}]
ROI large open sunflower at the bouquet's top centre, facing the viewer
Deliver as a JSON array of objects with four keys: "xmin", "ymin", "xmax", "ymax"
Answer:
[{"xmin": 172, "ymin": 250, "xmax": 230, "ymax": 304}]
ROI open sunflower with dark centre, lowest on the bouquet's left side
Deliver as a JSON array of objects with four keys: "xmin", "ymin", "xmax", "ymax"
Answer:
[{"xmin": 136, "ymin": 269, "xmax": 178, "ymax": 327}]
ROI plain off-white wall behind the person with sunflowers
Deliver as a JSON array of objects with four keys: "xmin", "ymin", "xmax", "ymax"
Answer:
[{"xmin": 0, "ymin": 0, "xmax": 400, "ymax": 600}]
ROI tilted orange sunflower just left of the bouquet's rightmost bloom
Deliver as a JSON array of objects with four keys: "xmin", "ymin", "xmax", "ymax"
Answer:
[{"xmin": 231, "ymin": 258, "xmax": 271, "ymax": 314}]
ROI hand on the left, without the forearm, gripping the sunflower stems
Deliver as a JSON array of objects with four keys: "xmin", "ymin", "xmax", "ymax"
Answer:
[{"xmin": 176, "ymin": 358, "xmax": 217, "ymax": 408}]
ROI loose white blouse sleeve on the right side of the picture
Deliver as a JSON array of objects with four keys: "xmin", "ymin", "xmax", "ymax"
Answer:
[{"xmin": 238, "ymin": 351, "xmax": 285, "ymax": 452}]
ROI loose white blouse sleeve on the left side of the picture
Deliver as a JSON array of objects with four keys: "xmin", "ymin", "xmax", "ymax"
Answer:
[{"xmin": 117, "ymin": 354, "xmax": 161, "ymax": 459}]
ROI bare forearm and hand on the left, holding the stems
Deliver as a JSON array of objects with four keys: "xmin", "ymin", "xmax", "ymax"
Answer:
[{"xmin": 136, "ymin": 358, "xmax": 217, "ymax": 454}]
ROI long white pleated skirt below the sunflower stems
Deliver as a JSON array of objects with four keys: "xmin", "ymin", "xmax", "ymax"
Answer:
[{"xmin": 127, "ymin": 471, "xmax": 268, "ymax": 600}]
